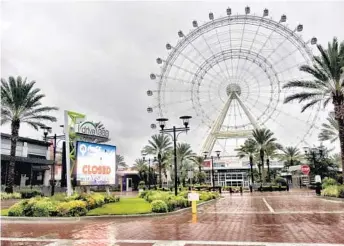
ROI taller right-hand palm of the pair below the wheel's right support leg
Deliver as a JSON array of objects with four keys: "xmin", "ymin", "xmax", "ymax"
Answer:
[{"xmin": 252, "ymin": 128, "xmax": 276, "ymax": 181}]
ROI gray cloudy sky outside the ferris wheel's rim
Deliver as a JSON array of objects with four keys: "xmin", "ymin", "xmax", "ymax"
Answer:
[{"xmin": 1, "ymin": 1, "xmax": 344, "ymax": 164}]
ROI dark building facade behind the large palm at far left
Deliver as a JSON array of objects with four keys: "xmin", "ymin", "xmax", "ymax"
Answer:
[{"xmin": 1, "ymin": 133, "xmax": 53, "ymax": 187}]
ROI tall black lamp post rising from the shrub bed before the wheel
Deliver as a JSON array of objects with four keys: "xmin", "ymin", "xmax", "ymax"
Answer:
[{"xmin": 156, "ymin": 116, "xmax": 192, "ymax": 196}]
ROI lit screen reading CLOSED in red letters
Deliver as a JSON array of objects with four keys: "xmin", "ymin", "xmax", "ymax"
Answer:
[{"xmin": 76, "ymin": 141, "xmax": 116, "ymax": 185}]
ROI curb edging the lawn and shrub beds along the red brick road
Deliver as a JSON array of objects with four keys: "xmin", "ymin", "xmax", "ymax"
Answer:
[{"xmin": 0, "ymin": 197, "xmax": 222, "ymax": 222}]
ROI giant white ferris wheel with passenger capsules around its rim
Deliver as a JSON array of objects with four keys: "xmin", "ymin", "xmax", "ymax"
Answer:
[{"xmin": 147, "ymin": 7, "xmax": 320, "ymax": 154}]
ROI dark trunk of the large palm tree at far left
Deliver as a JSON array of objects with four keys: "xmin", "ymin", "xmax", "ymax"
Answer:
[{"xmin": 5, "ymin": 120, "xmax": 20, "ymax": 193}]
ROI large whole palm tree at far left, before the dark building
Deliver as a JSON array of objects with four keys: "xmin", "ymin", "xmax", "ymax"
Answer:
[{"xmin": 1, "ymin": 76, "xmax": 58, "ymax": 193}]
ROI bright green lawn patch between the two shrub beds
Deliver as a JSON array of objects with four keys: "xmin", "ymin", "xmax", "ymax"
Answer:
[{"xmin": 87, "ymin": 197, "xmax": 152, "ymax": 215}]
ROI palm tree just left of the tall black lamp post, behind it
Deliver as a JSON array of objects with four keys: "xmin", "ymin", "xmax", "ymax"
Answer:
[{"xmin": 142, "ymin": 134, "xmax": 172, "ymax": 188}]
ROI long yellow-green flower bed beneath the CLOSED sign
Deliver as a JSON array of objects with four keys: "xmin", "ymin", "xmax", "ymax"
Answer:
[{"xmin": 8, "ymin": 193, "xmax": 119, "ymax": 217}]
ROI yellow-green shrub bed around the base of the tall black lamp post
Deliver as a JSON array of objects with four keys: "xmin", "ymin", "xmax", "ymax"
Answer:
[{"xmin": 139, "ymin": 190, "xmax": 220, "ymax": 213}]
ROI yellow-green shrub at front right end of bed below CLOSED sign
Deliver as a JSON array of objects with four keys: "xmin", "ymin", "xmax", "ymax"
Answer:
[{"xmin": 56, "ymin": 200, "xmax": 87, "ymax": 217}]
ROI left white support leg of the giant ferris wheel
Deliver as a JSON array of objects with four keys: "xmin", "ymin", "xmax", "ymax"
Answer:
[{"xmin": 201, "ymin": 93, "xmax": 235, "ymax": 154}]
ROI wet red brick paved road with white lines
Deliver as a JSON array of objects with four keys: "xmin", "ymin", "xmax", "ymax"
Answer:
[{"xmin": 1, "ymin": 192, "xmax": 344, "ymax": 246}]
